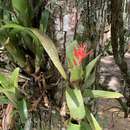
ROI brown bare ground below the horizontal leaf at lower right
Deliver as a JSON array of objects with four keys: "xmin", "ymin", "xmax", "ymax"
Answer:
[{"xmin": 98, "ymin": 99, "xmax": 130, "ymax": 130}]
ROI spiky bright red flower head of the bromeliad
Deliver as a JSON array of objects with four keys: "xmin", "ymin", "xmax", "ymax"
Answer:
[{"xmin": 73, "ymin": 44, "xmax": 93, "ymax": 65}]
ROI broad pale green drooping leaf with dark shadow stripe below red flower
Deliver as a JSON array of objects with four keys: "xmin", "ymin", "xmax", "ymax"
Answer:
[{"xmin": 66, "ymin": 88, "xmax": 85, "ymax": 119}]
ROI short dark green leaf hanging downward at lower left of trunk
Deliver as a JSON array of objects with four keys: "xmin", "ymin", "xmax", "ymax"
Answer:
[{"xmin": 17, "ymin": 99, "xmax": 28, "ymax": 123}]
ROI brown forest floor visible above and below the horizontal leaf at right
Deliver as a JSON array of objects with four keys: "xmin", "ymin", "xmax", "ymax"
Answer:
[{"xmin": 97, "ymin": 53, "xmax": 130, "ymax": 130}]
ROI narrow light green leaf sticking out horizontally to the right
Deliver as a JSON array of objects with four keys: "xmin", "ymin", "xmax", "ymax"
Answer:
[{"xmin": 83, "ymin": 89, "xmax": 123, "ymax": 98}]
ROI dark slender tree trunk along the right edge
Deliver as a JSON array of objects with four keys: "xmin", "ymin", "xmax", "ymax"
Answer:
[{"xmin": 111, "ymin": 0, "xmax": 130, "ymax": 116}]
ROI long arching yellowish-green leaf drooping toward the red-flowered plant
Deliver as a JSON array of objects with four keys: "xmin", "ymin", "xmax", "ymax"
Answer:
[{"xmin": 1, "ymin": 24, "xmax": 67, "ymax": 79}]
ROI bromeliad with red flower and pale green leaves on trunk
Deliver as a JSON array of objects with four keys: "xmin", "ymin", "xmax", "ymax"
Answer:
[{"xmin": 66, "ymin": 41, "xmax": 122, "ymax": 130}]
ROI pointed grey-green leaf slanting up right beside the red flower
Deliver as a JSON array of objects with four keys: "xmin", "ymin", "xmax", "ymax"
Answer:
[{"xmin": 85, "ymin": 55, "xmax": 100, "ymax": 80}]
